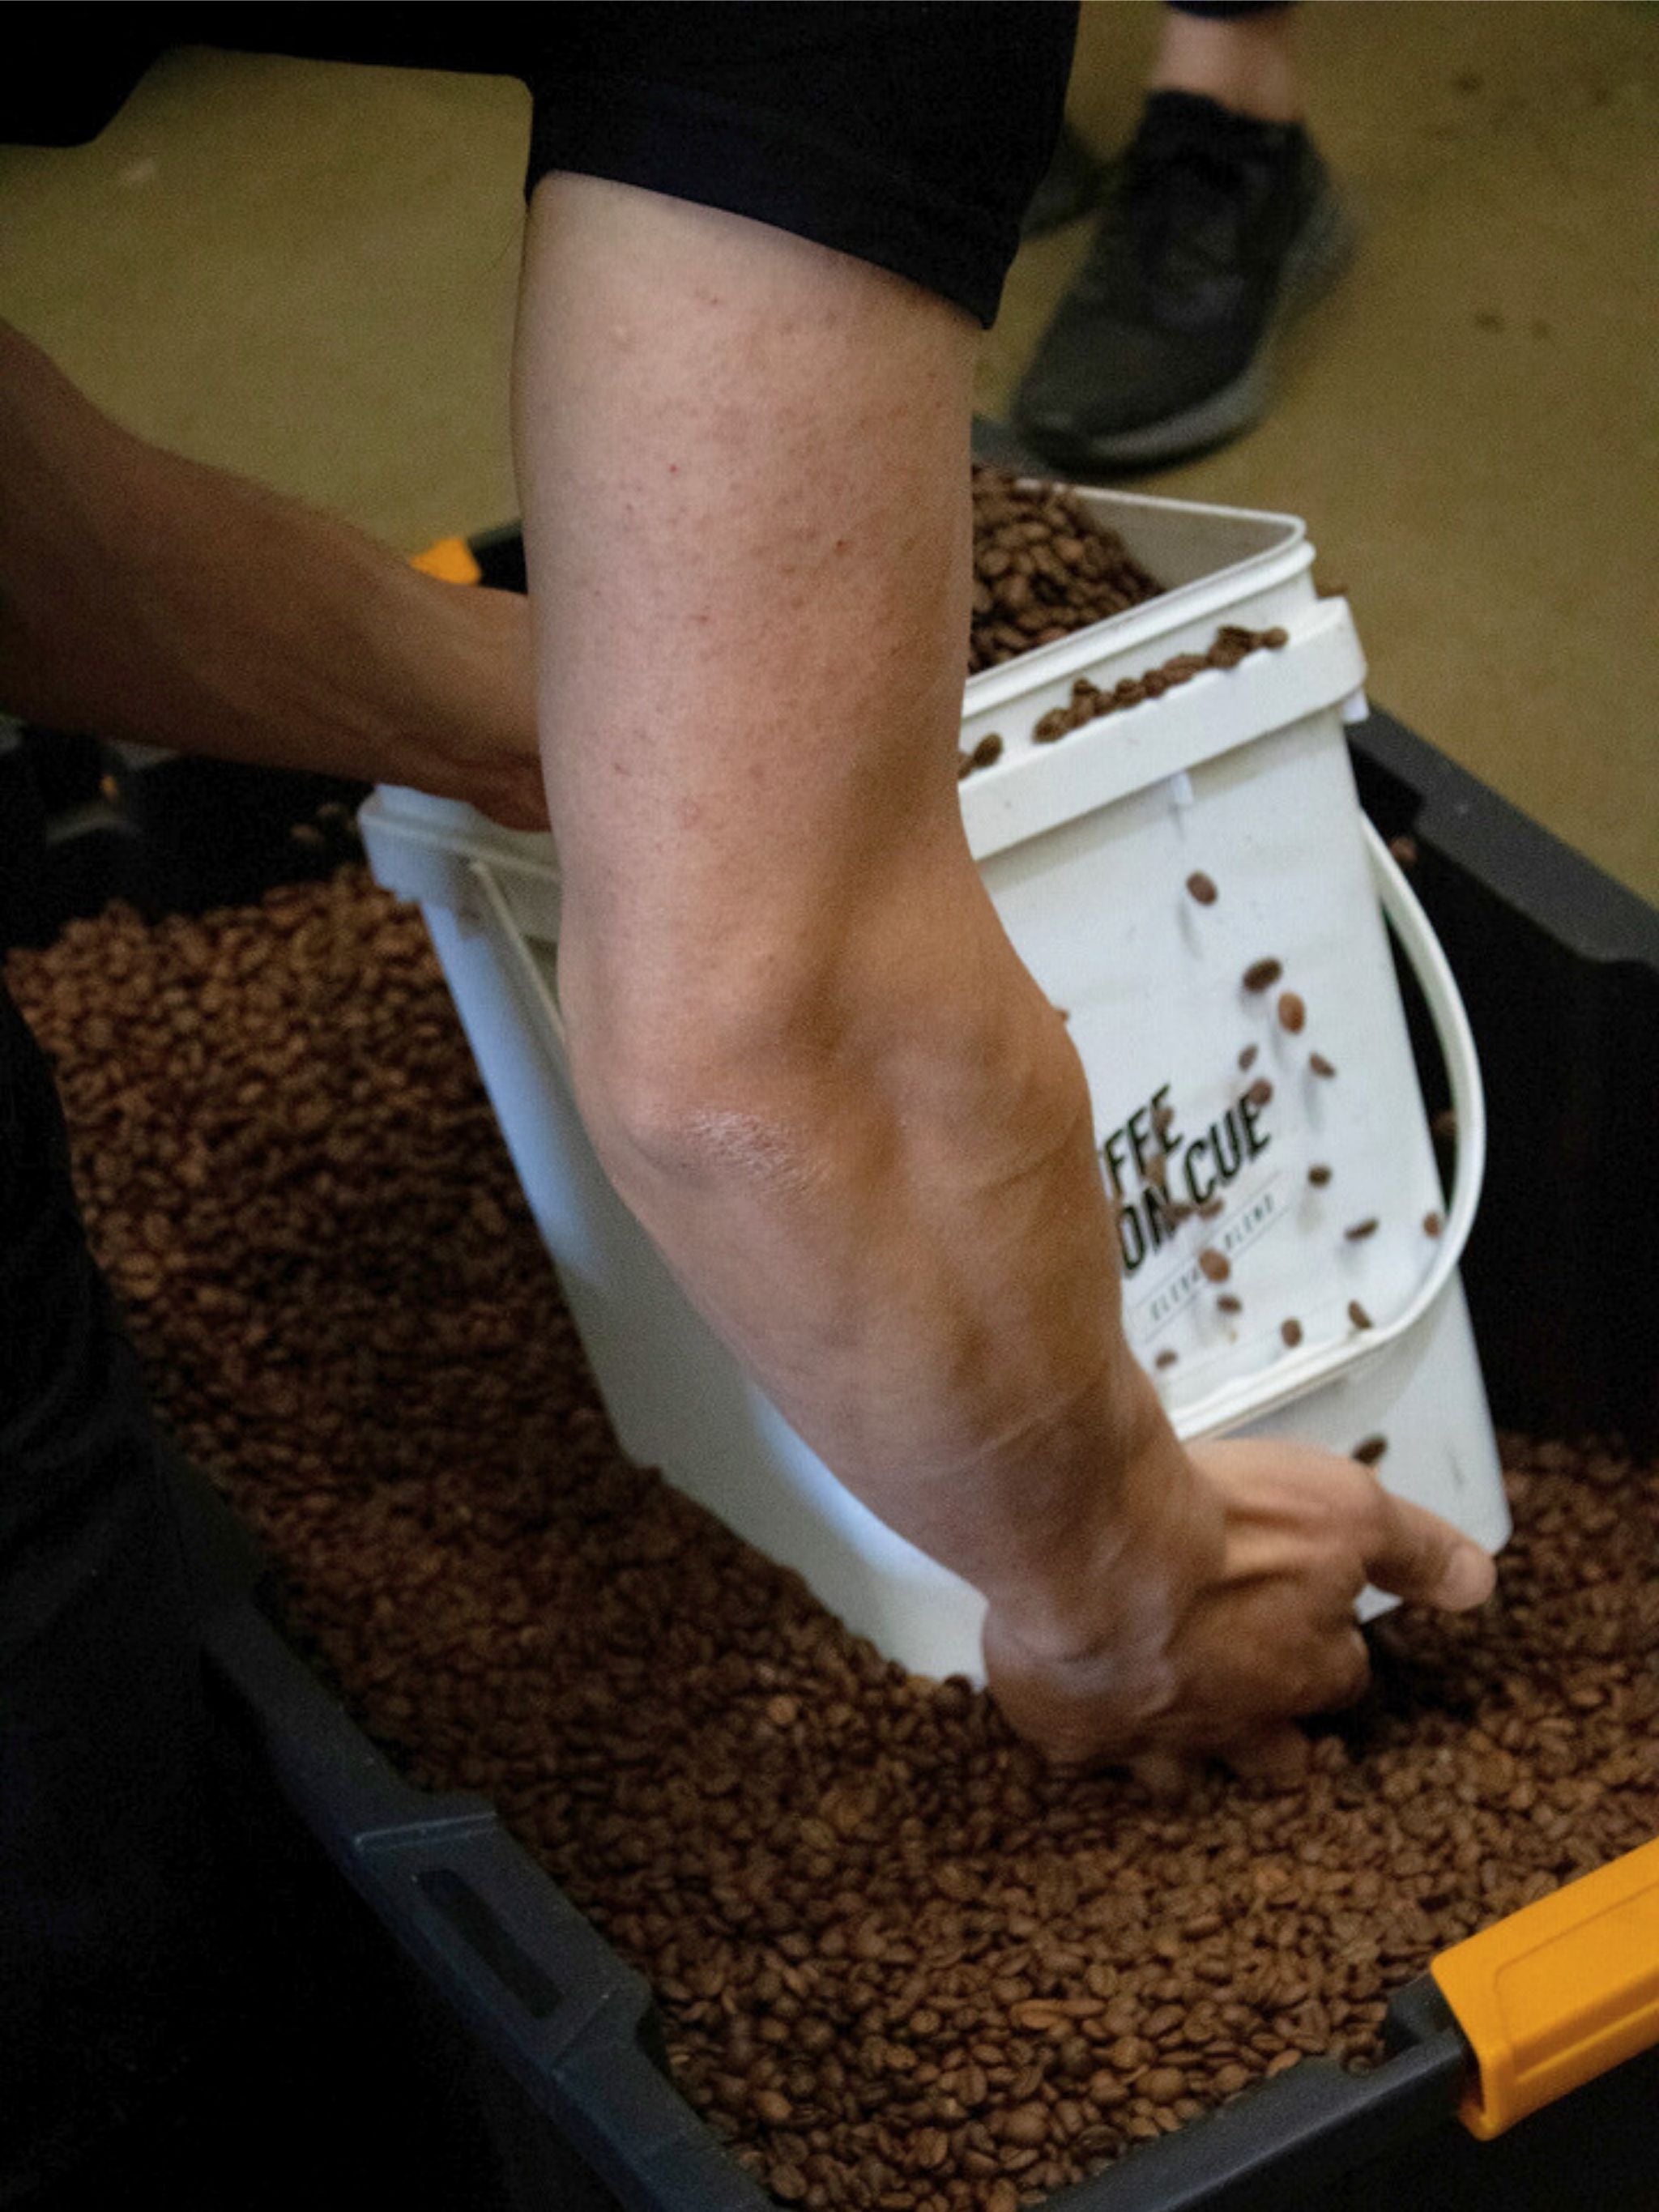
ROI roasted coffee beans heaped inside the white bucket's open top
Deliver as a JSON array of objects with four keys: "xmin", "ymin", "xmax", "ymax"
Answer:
[{"xmin": 969, "ymin": 462, "xmax": 1163, "ymax": 675}]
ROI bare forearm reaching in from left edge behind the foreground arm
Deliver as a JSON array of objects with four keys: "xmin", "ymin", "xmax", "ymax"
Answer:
[{"xmin": 0, "ymin": 325, "xmax": 546, "ymax": 827}]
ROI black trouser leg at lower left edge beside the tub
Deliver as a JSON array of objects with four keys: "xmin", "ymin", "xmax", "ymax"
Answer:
[{"xmin": 0, "ymin": 984, "xmax": 215, "ymax": 2203}]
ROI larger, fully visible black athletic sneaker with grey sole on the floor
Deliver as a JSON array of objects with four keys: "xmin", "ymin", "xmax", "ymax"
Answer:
[{"xmin": 1013, "ymin": 93, "xmax": 1351, "ymax": 469}]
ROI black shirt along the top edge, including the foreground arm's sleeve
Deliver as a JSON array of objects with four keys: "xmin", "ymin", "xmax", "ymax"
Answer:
[{"xmin": 0, "ymin": 0, "xmax": 1077, "ymax": 323}]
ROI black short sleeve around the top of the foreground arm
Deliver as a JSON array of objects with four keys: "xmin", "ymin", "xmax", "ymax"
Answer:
[{"xmin": 524, "ymin": 0, "xmax": 1077, "ymax": 323}]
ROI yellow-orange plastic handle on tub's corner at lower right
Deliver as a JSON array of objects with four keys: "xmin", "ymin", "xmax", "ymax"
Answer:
[{"xmin": 1429, "ymin": 1840, "xmax": 1659, "ymax": 2139}]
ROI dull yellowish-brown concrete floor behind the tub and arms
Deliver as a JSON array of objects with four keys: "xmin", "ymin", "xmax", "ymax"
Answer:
[{"xmin": 0, "ymin": 0, "xmax": 1659, "ymax": 898}]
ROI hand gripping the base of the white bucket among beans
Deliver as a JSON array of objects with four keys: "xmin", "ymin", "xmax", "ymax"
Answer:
[{"xmin": 984, "ymin": 1438, "xmax": 1495, "ymax": 1785}]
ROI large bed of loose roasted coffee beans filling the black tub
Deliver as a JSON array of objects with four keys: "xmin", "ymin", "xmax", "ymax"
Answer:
[{"xmin": 9, "ymin": 872, "xmax": 1659, "ymax": 2212}]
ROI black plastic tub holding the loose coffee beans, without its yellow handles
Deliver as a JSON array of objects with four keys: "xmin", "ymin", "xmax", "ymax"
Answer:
[{"xmin": 16, "ymin": 557, "xmax": 1659, "ymax": 2212}]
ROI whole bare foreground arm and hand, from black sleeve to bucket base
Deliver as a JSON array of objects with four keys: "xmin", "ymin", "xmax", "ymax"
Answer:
[{"xmin": 515, "ymin": 175, "xmax": 1491, "ymax": 1763}]
